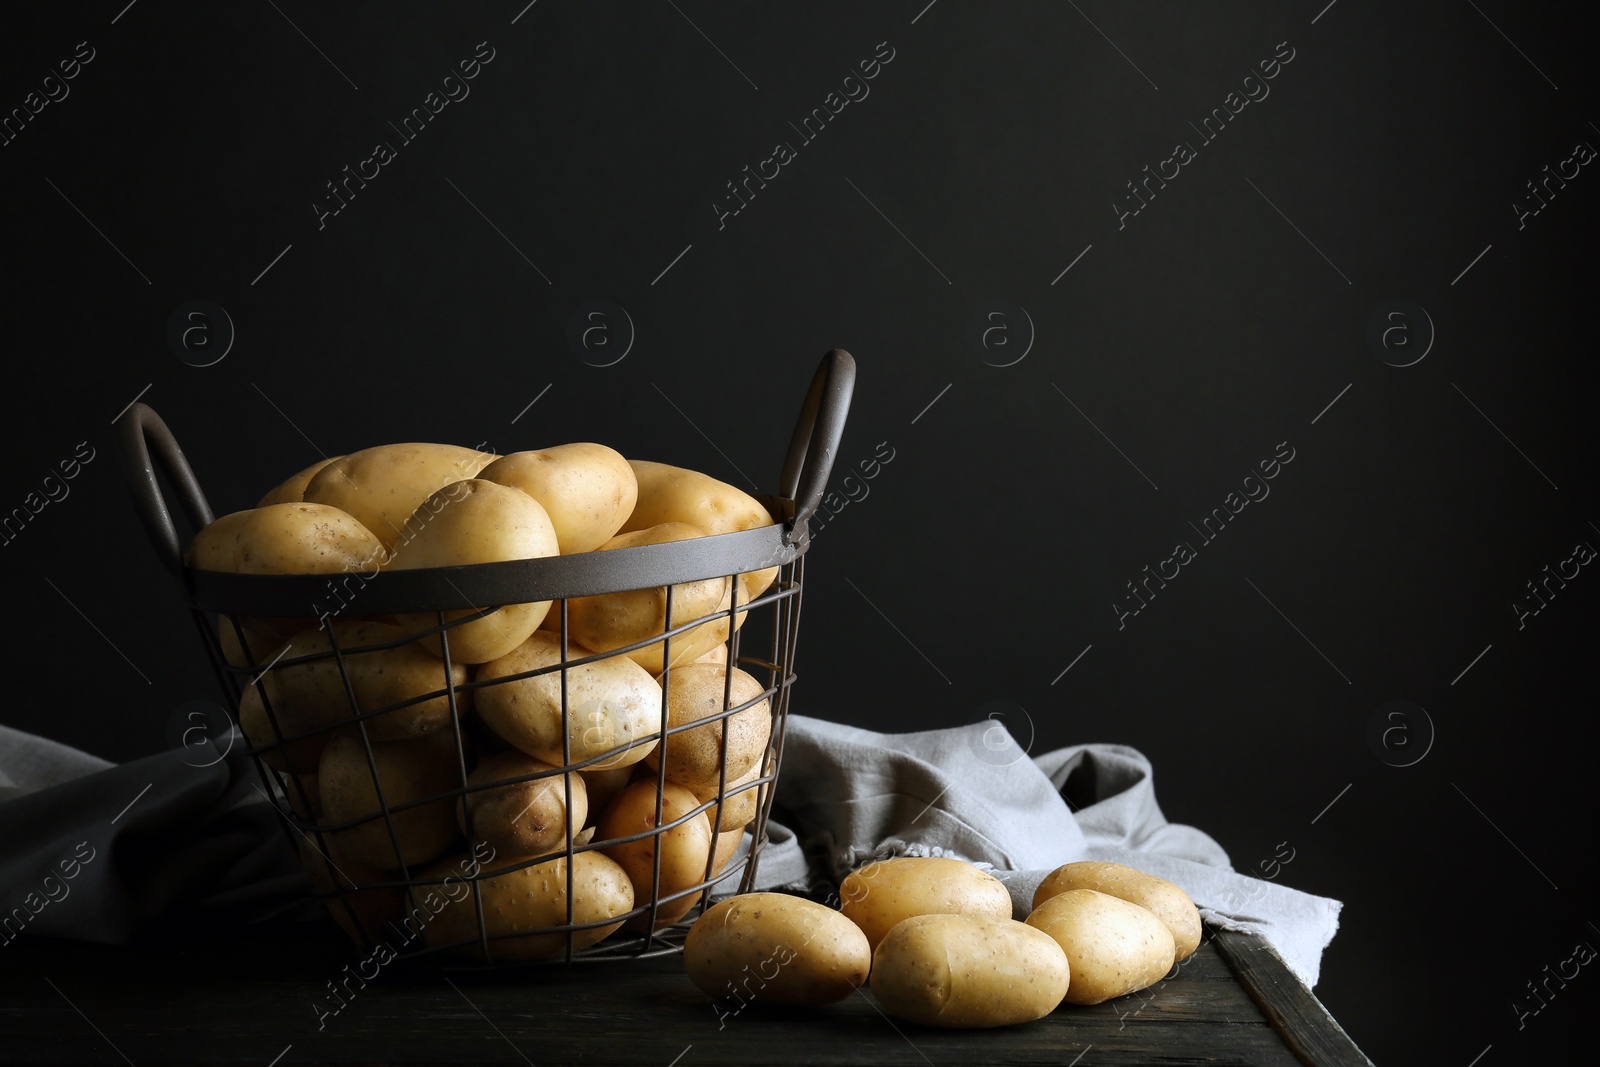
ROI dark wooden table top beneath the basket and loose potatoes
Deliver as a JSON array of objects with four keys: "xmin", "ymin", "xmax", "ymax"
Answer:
[{"xmin": 0, "ymin": 921, "xmax": 1368, "ymax": 1067}]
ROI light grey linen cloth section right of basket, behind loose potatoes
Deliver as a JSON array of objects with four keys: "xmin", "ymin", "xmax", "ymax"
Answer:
[{"xmin": 757, "ymin": 715, "xmax": 1342, "ymax": 987}]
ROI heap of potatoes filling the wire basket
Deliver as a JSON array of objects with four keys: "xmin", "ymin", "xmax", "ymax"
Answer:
[{"xmin": 187, "ymin": 443, "xmax": 776, "ymax": 961}]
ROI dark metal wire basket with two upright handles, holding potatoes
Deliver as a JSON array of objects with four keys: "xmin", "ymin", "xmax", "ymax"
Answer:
[{"xmin": 122, "ymin": 349, "xmax": 854, "ymax": 966}]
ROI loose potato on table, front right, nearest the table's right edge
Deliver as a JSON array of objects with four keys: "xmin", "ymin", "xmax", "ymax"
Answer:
[{"xmin": 1027, "ymin": 889, "xmax": 1174, "ymax": 1005}]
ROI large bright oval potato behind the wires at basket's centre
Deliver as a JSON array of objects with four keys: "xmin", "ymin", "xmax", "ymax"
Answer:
[{"xmin": 475, "ymin": 630, "xmax": 662, "ymax": 771}]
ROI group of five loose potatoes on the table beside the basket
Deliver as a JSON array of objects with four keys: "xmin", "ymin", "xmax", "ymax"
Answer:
[{"xmin": 683, "ymin": 857, "xmax": 1200, "ymax": 1027}]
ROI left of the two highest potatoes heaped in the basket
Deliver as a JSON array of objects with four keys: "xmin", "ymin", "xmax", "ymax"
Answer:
[{"xmin": 304, "ymin": 443, "xmax": 499, "ymax": 550}]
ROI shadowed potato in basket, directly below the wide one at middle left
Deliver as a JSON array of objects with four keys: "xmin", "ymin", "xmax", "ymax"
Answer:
[{"xmin": 317, "ymin": 731, "xmax": 461, "ymax": 870}]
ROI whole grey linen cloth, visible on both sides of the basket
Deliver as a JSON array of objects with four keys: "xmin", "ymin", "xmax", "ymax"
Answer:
[{"xmin": 0, "ymin": 715, "xmax": 1341, "ymax": 985}]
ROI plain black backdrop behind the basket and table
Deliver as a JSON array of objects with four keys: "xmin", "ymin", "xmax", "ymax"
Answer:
[{"xmin": 0, "ymin": 0, "xmax": 1600, "ymax": 1065}]
